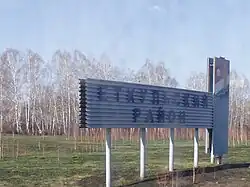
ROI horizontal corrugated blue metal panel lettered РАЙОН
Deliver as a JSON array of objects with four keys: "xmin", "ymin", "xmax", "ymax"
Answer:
[{"xmin": 79, "ymin": 79, "xmax": 213, "ymax": 128}]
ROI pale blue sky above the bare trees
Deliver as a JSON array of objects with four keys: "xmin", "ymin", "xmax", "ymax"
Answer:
[{"xmin": 0, "ymin": 0, "xmax": 250, "ymax": 84}]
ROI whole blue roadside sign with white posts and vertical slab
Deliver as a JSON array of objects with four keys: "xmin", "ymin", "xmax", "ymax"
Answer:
[{"xmin": 80, "ymin": 57, "xmax": 230, "ymax": 187}]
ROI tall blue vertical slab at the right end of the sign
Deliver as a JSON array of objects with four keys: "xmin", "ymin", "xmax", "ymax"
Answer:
[{"xmin": 213, "ymin": 57, "xmax": 230, "ymax": 156}]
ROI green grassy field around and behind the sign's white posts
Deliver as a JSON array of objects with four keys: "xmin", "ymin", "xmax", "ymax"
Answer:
[{"xmin": 0, "ymin": 136, "xmax": 250, "ymax": 187}]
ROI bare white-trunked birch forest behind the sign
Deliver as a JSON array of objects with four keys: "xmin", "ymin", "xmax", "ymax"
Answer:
[{"xmin": 0, "ymin": 49, "xmax": 250, "ymax": 143}]
